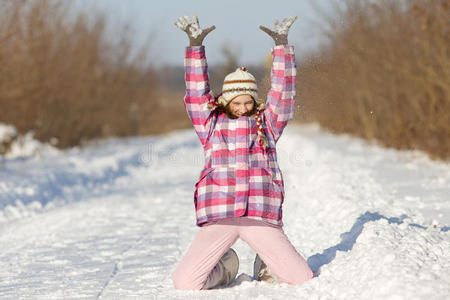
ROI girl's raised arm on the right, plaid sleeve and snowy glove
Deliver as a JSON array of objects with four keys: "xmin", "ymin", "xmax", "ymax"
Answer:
[{"xmin": 260, "ymin": 17, "xmax": 297, "ymax": 141}]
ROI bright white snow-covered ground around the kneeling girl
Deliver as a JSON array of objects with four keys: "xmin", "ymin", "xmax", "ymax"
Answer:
[{"xmin": 0, "ymin": 125, "xmax": 450, "ymax": 300}]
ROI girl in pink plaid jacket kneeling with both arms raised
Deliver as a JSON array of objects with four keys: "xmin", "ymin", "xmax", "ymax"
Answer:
[{"xmin": 172, "ymin": 16, "xmax": 313, "ymax": 290}]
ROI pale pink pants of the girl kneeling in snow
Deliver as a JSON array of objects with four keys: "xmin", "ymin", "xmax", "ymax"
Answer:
[{"xmin": 172, "ymin": 217, "xmax": 313, "ymax": 290}]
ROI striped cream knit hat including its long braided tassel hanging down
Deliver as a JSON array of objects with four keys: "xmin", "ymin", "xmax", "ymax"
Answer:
[{"xmin": 208, "ymin": 67, "xmax": 269, "ymax": 148}]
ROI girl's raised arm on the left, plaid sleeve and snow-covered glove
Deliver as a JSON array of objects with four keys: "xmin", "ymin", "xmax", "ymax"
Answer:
[{"xmin": 175, "ymin": 16, "xmax": 215, "ymax": 147}]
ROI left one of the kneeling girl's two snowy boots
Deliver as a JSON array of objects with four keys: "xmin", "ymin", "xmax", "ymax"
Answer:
[{"xmin": 202, "ymin": 248, "xmax": 239, "ymax": 290}]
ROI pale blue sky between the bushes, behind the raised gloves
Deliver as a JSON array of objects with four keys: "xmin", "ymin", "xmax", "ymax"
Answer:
[{"xmin": 75, "ymin": 0, "xmax": 332, "ymax": 65}]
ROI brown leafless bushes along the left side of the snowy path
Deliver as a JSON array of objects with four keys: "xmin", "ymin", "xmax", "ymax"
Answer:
[{"xmin": 0, "ymin": 0, "xmax": 163, "ymax": 148}]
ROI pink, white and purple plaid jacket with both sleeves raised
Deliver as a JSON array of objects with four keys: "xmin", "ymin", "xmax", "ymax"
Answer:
[{"xmin": 184, "ymin": 45, "xmax": 296, "ymax": 226}]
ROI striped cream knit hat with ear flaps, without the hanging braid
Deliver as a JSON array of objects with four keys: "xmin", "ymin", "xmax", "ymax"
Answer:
[{"xmin": 208, "ymin": 67, "xmax": 264, "ymax": 110}]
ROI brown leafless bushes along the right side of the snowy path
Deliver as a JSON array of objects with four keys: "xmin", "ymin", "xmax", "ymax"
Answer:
[{"xmin": 297, "ymin": 0, "xmax": 450, "ymax": 159}]
